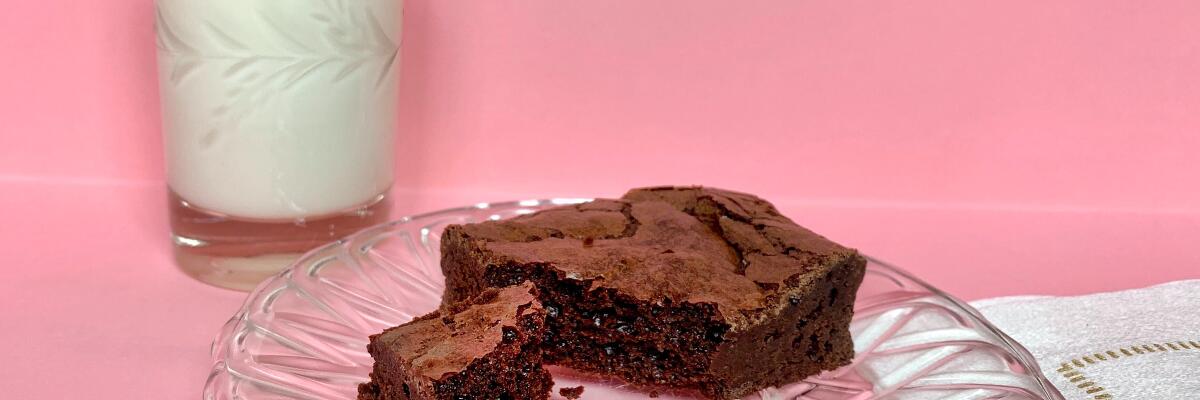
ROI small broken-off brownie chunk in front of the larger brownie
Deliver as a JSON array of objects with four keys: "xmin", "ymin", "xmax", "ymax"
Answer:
[{"xmin": 359, "ymin": 283, "xmax": 553, "ymax": 400}]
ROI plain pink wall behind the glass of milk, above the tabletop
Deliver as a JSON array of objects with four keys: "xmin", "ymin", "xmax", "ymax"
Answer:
[{"xmin": 0, "ymin": 0, "xmax": 1200, "ymax": 211}]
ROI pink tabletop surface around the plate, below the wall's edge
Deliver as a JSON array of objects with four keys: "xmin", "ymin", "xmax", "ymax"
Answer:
[{"xmin": 0, "ymin": 183, "xmax": 1200, "ymax": 399}]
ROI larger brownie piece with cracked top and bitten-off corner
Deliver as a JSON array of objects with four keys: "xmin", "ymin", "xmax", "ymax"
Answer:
[{"xmin": 442, "ymin": 187, "xmax": 865, "ymax": 399}]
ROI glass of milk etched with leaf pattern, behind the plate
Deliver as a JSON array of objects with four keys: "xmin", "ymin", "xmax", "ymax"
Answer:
[{"xmin": 156, "ymin": 0, "xmax": 400, "ymax": 289}]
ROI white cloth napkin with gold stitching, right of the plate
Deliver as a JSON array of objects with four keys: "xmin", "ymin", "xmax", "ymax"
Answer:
[{"xmin": 973, "ymin": 280, "xmax": 1200, "ymax": 400}]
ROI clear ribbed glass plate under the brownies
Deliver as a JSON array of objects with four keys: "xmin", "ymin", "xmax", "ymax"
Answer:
[{"xmin": 204, "ymin": 199, "xmax": 1062, "ymax": 400}]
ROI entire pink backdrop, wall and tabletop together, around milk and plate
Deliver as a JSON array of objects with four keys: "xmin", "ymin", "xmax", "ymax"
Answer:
[{"xmin": 0, "ymin": 0, "xmax": 1200, "ymax": 399}]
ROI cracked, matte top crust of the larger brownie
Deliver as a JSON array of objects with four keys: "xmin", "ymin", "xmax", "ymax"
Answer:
[{"xmin": 448, "ymin": 187, "xmax": 857, "ymax": 330}]
